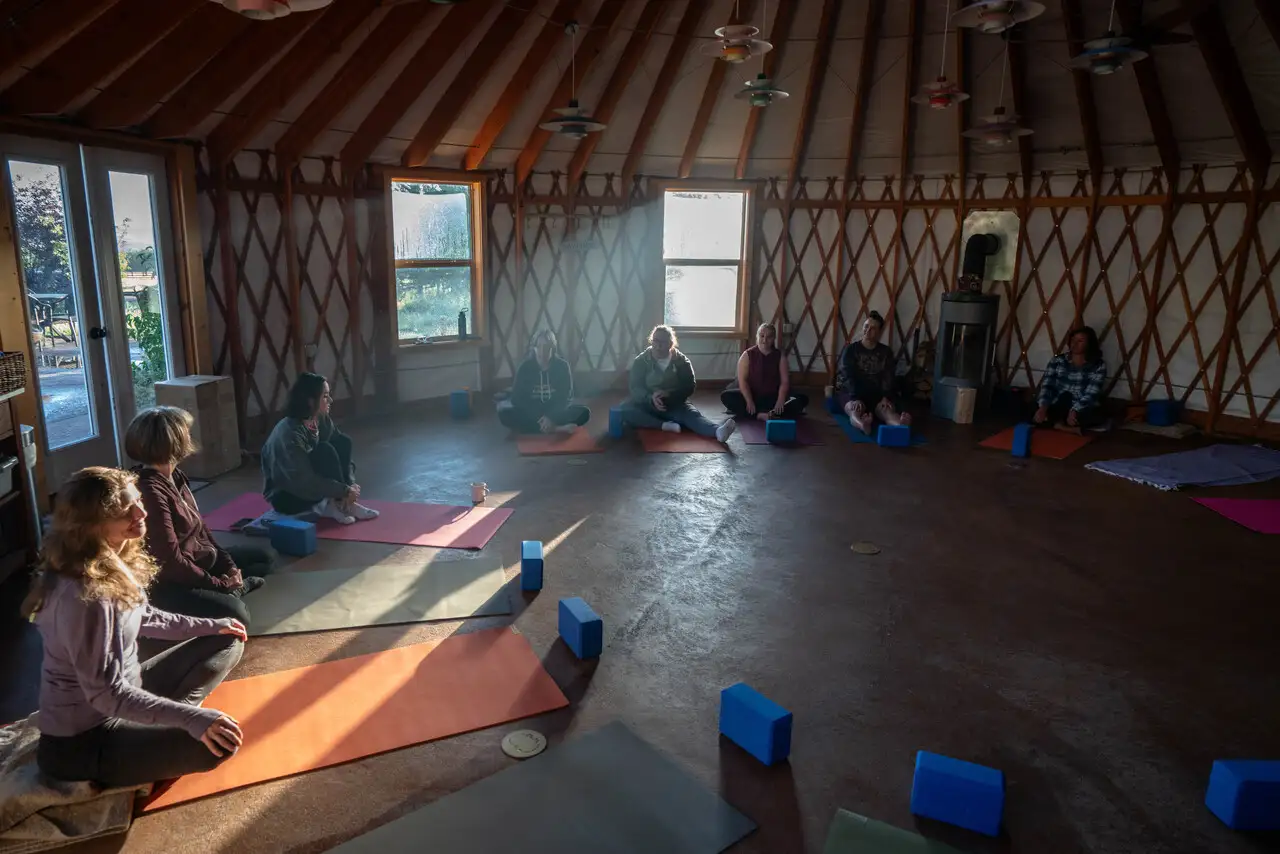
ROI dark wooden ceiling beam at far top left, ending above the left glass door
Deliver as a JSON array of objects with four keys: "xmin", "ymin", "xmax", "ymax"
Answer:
[{"xmin": 0, "ymin": 0, "xmax": 202, "ymax": 115}]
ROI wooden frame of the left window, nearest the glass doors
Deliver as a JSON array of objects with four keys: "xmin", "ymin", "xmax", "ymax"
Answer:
[{"xmin": 379, "ymin": 168, "xmax": 489, "ymax": 350}]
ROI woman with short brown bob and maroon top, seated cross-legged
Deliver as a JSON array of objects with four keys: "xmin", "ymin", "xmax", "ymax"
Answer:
[{"xmin": 124, "ymin": 406, "xmax": 271, "ymax": 626}]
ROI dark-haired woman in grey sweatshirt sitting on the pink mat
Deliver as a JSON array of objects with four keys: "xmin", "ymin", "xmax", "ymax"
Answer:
[{"xmin": 262, "ymin": 374, "xmax": 378, "ymax": 525}]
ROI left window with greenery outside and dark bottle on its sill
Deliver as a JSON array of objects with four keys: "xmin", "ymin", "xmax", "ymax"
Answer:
[{"xmin": 388, "ymin": 173, "xmax": 484, "ymax": 344}]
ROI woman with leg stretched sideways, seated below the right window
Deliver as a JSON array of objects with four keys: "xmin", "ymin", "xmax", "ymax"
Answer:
[{"xmin": 622, "ymin": 326, "xmax": 737, "ymax": 442}]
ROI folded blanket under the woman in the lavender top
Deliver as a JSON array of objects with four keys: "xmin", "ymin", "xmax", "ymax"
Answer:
[{"xmin": 0, "ymin": 714, "xmax": 151, "ymax": 854}]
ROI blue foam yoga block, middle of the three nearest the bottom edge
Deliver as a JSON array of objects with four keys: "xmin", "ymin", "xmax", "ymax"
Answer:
[{"xmin": 911, "ymin": 750, "xmax": 1005, "ymax": 836}]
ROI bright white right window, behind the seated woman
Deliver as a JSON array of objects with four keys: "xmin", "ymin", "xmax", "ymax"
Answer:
[{"xmin": 662, "ymin": 188, "xmax": 750, "ymax": 334}]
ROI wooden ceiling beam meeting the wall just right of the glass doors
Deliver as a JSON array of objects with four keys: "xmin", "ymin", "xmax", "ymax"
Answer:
[{"xmin": 209, "ymin": 0, "xmax": 381, "ymax": 166}]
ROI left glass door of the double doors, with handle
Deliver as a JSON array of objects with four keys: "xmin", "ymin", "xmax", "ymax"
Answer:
[{"xmin": 0, "ymin": 136, "xmax": 118, "ymax": 488}]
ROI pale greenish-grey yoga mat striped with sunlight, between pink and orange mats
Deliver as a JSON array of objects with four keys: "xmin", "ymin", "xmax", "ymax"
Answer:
[{"xmin": 246, "ymin": 554, "xmax": 511, "ymax": 636}]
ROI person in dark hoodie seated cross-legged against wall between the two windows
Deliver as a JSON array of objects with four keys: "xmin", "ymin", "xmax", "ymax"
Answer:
[{"xmin": 498, "ymin": 329, "xmax": 591, "ymax": 433}]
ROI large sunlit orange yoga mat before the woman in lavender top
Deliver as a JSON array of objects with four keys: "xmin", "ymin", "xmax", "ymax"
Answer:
[{"xmin": 146, "ymin": 629, "xmax": 568, "ymax": 818}]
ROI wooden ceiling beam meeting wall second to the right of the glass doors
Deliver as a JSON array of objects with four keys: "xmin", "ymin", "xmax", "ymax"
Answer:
[{"xmin": 275, "ymin": 3, "xmax": 431, "ymax": 163}]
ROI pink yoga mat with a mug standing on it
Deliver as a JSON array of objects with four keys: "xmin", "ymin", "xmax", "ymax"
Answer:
[{"xmin": 205, "ymin": 493, "xmax": 512, "ymax": 548}]
